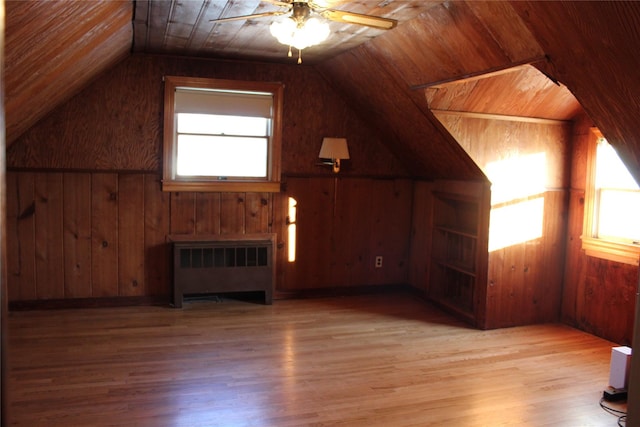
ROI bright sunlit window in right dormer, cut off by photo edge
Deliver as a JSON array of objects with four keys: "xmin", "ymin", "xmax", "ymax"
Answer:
[{"xmin": 582, "ymin": 129, "xmax": 640, "ymax": 265}]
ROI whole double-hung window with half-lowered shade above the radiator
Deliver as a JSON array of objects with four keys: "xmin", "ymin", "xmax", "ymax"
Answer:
[{"xmin": 162, "ymin": 77, "xmax": 283, "ymax": 192}]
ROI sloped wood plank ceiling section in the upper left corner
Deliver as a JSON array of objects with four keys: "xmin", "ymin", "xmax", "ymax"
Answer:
[{"xmin": 4, "ymin": 1, "xmax": 133, "ymax": 145}]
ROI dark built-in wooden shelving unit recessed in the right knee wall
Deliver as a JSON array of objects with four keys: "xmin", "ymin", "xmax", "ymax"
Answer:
[{"xmin": 428, "ymin": 183, "xmax": 487, "ymax": 324}]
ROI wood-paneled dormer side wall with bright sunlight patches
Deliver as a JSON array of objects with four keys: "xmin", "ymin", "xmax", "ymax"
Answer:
[{"xmin": 437, "ymin": 113, "xmax": 571, "ymax": 328}]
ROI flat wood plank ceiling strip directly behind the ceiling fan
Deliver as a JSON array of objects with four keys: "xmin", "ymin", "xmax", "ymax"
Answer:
[{"xmin": 134, "ymin": 0, "xmax": 441, "ymax": 64}]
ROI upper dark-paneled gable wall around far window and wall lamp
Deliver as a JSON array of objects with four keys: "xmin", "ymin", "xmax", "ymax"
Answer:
[{"xmin": 7, "ymin": 55, "xmax": 408, "ymax": 177}]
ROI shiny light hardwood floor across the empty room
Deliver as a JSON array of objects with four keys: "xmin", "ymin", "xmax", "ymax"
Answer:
[{"xmin": 8, "ymin": 293, "xmax": 617, "ymax": 427}]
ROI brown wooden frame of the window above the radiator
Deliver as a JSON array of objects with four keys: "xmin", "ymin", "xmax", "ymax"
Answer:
[{"xmin": 162, "ymin": 76, "xmax": 284, "ymax": 192}]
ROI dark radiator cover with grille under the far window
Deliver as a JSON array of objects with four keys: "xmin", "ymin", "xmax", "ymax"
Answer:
[{"xmin": 173, "ymin": 234, "xmax": 274, "ymax": 308}]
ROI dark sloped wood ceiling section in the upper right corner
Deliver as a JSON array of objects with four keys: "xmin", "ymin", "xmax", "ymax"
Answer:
[{"xmin": 511, "ymin": 1, "xmax": 640, "ymax": 183}]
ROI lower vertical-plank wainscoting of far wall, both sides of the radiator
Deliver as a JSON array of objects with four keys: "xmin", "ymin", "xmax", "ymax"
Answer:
[{"xmin": 7, "ymin": 172, "xmax": 413, "ymax": 302}]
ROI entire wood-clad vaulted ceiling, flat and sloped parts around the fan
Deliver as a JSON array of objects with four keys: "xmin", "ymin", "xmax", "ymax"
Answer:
[{"xmin": 5, "ymin": 0, "xmax": 640, "ymax": 179}]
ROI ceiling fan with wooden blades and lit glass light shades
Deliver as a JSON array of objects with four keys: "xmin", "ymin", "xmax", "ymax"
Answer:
[{"xmin": 211, "ymin": 0, "xmax": 398, "ymax": 64}]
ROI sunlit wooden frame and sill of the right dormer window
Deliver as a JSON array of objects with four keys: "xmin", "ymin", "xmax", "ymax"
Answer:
[{"xmin": 582, "ymin": 128, "xmax": 640, "ymax": 265}]
